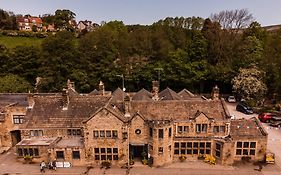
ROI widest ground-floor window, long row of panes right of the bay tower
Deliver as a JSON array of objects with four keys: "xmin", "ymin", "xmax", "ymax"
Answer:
[{"xmin": 174, "ymin": 142, "xmax": 211, "ymax": 155}]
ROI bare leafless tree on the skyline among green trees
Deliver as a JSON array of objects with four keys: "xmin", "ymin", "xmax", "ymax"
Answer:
[{"xmin": 211, "ymin": 9, "xmax": 253, "ymax": 29}]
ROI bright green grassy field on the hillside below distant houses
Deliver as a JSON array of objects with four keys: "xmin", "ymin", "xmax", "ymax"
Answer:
[{"xmin": 0, "ymin": 35, "xmax": 43, "ymax": 48}]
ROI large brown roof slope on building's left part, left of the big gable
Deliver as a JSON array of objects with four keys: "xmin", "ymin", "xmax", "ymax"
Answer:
[{"xmin": 23, "ymin": 95, "xmax": 110, "ymax": 128}]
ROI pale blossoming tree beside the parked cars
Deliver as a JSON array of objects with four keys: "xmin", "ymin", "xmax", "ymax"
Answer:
[{"xmin": 232, "ymin": 67, "xmax": 267, "ymax": 103}]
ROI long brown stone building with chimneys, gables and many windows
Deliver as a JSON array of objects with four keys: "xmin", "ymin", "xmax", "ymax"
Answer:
[{"xmin": 0, "ymin": 81, "xmax": 267, "ymax": 166}]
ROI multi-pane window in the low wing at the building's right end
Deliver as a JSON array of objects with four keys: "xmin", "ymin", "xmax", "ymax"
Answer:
[{"xmin": 236, "ymin": 142, "xmax": 256, "ymax": 156}]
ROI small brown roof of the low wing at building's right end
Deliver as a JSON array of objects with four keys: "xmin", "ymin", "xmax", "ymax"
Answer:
[{"xmin": 230, "ymin": 117, "xmax": 267, "ymax": 137}]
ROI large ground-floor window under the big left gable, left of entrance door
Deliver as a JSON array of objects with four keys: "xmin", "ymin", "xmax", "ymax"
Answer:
[{"xmin": 94, "ymin": 148, "xmax": 118, "ymax": 160}]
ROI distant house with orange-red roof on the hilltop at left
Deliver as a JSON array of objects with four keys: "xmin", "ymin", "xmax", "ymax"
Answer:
[{"xmin": 17, "ymin": 16, "xmax": 43, "ymax": 31}]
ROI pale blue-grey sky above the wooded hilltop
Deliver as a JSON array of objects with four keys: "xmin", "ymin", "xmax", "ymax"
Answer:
[{"xmin": 0, "ymin": 0, "xmax": 281, "ymax": 26}]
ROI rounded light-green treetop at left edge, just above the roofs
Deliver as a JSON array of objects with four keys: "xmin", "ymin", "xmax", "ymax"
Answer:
[{"xmin": 0, "ymin": 74, "xmax": 33, "ymax": 93}]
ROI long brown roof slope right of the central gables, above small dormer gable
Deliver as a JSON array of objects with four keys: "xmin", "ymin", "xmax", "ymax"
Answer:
[{"xmin": 131, "ymin": 100, "xmax": 229, "ymax": 121}]
